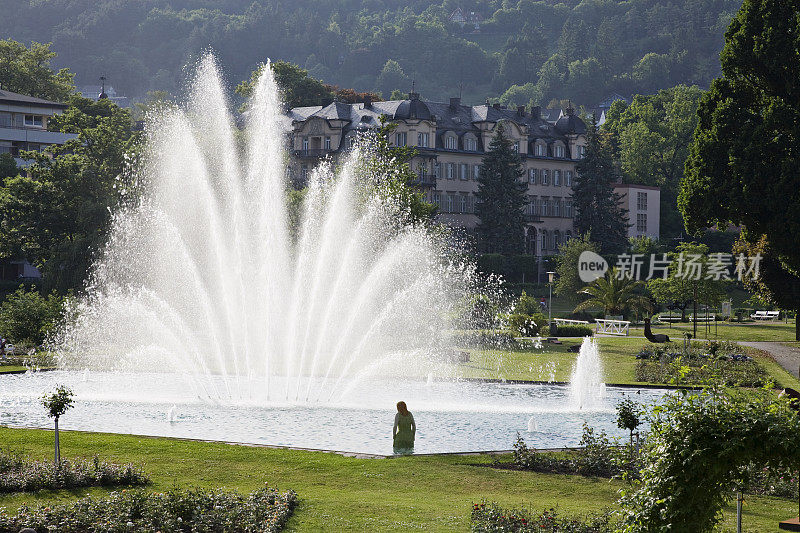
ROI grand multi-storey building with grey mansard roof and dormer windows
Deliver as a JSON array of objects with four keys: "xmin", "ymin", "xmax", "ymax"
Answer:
[{"xmin": 288, "ymin": 93, "xmax": 586, "ymax": 256}]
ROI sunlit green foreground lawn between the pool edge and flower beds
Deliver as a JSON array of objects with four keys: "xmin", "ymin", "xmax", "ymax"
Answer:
[{"xmin": 0, "ymin": 428, "xmax": 797, "ymax": 532}]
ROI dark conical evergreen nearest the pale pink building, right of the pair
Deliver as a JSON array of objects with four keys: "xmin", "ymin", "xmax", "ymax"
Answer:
[{"xmin": 572, "ymin": 117, "xmax": 628, "ymax": 254}]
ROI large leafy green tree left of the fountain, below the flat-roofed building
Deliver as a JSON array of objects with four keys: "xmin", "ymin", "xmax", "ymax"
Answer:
[{"xmin": 0, "ymin": 96, "xmax": 138, "ymax": 292}]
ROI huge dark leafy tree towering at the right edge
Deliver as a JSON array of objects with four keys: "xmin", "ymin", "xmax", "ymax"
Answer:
[{"xmin": 678, "ymin": 0, "xmax": 800, "ymax": 340}]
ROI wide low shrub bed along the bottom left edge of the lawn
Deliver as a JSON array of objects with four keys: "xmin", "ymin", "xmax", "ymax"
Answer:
[{"xmin": 0, "ymin": 487, "xmax": 297, "ymax": 533}]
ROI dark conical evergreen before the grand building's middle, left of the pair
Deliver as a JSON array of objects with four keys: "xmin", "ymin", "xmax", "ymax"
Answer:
[{"xmin": 475, "ymin": 122, "xmax": 528, "ymax": 254}]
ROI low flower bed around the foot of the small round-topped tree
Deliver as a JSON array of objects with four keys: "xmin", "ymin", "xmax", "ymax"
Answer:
[{"xmin": 0, "ymin": 450, "xmax": 150, "ymax": 493}]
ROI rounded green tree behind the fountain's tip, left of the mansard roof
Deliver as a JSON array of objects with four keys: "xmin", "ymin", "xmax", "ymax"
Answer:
[{"xmin": 235, "ymin": 61, "xmax": 333, "ymax": 108}]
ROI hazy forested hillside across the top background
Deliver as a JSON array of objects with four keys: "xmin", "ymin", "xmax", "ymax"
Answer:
[{"xmin": 0, "ymin": 0, "xmax": 741, "ymax": 105}]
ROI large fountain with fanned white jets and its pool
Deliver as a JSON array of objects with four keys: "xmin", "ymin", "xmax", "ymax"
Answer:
[{"xmin": 0, "ymin": 58, "xmax": 659, "ymax": 453}]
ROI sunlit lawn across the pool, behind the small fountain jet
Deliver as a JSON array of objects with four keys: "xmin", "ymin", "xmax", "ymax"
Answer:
[{"xmin": 460, "ymin": 337, "xmax": 800, "ymax": 387}]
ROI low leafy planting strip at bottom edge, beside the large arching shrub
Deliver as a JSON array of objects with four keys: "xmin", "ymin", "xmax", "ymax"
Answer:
[{"xmin": 471, "ymin": 501, "xmax": 615, "ymax": 533}]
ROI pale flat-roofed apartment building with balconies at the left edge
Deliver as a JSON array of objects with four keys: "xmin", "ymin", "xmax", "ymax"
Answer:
[{"xmin": 0, "ymin": 89, "xmax": 77, "ymax": 167}]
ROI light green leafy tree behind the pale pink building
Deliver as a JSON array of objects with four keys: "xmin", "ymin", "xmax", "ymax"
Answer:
[{"xmin": 603, "ymin": 85, "xmax": 702, "ymax": 239}]
